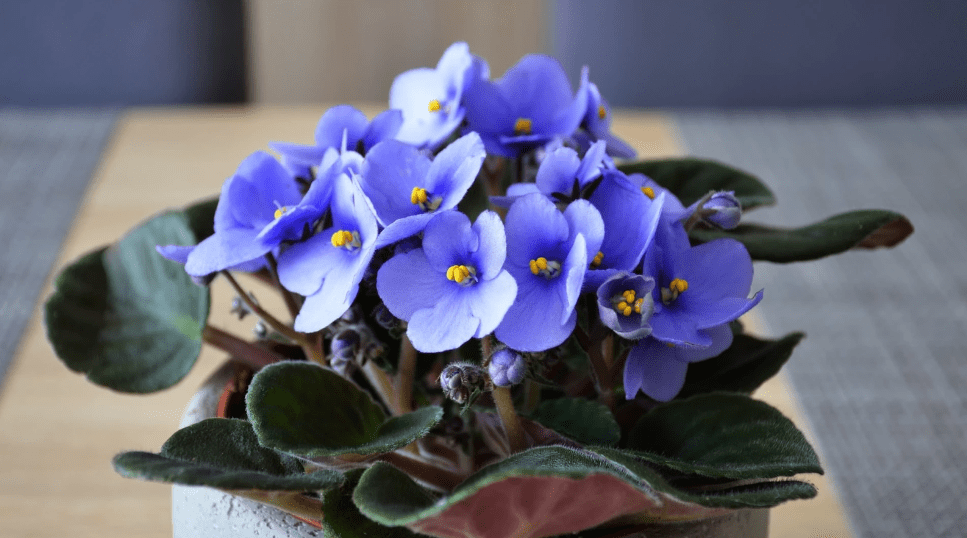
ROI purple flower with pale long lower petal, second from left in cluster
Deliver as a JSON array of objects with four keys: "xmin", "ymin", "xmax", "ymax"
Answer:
[{"xmin": 279, "ymin": 174, "xmax": 377, "ymax": 332}]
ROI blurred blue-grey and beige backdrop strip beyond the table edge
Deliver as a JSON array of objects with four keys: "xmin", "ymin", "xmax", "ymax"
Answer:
[{"xmin": 0, "ymin": 0, "xmax": 967, "ymax": 107}]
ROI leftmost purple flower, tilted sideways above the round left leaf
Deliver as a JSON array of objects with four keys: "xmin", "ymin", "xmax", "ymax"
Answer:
[{"xmin": 157, "ymin": 151, "xmax": 308, "ymax": 278}]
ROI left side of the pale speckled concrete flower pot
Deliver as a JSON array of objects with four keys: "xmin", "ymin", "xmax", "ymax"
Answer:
[{"xmin": 171, "ymin": 362, "xmax": 323, "ymax": 538}]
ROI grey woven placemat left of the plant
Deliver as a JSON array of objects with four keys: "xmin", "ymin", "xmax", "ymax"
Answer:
[{"xmin": 0, "ymin": 108, "xmax": 117, "ymax": 392}]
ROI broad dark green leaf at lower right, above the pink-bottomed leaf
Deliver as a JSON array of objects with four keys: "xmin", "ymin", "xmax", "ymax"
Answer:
[{"xmin": 627, "ymin": 393, "xmax": 823, "ymax": 479}]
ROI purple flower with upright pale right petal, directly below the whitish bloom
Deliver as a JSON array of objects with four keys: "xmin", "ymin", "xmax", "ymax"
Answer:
[{"xmin": 360, "ymin": 133, "xmax": 485, "ymax": 248}]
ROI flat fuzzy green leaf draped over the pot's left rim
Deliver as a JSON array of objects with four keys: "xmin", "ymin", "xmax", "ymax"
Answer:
[{"xmin": 114, "ymin": 418, "xmax": 343, "ymax": 492}]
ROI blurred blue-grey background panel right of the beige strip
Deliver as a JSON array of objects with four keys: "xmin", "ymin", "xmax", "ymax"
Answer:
[{"xmin": 549, "ymin": 0, "xmax": 967, "ymax": 107}]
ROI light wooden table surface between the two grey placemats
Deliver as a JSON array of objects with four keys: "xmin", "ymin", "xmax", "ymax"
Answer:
[{"xmin": 0, "ymin": 105, "xmax": 851, "ymax": 538}]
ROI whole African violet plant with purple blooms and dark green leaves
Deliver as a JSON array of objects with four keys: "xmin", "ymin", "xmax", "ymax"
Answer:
[{"xmin": 46, "ymin": 43, "xmax": 912, "ymax": 537}]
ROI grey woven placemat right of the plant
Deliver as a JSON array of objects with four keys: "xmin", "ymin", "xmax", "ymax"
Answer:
[{"xmin": 675, "ymin": 108, "xmax": 967, "ymax": 538}]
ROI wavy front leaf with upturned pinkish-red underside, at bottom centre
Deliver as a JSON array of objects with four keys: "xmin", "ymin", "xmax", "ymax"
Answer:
[{"xmin": 353, "ymin": 446, "xmax": 816, "ymax": 538}]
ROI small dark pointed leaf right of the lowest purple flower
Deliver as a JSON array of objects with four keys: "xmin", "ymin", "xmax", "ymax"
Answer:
[{"xmin": 676, "ymin": 332, "xmax": 806, "ymax": 399}]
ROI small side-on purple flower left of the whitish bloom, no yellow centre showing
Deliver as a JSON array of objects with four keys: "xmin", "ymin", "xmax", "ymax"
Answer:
[{"xmin": 269, "ymin": 105, "xmax": 403, "ymax": 177}]
